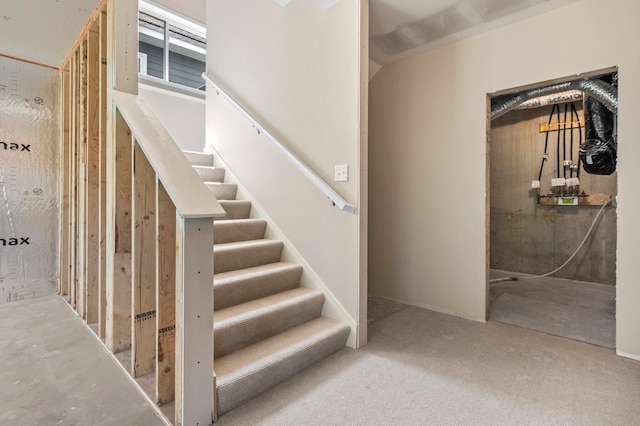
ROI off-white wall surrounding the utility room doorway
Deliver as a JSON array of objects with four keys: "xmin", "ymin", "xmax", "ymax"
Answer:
[{"xmin": 369, "ymin": 0, "xmax": 640, "ymax": 359}]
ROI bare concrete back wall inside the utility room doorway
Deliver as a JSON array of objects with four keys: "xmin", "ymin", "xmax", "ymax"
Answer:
[{"xmin": 490, "ymin": 105, "xmax": 617, "ymax": 285}]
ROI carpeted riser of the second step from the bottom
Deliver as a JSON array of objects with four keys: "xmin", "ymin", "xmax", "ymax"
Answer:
[{"xmin": 214, "ymin": 292, "xmax": 324, "ymax": 358}]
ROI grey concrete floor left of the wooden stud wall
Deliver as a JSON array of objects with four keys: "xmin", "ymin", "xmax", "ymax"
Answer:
[{"xmin": 0, "ymin": 295, "xmax": 165, "ymax": 426}]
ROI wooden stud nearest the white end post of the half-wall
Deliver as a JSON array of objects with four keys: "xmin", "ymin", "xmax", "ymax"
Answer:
[{"xmin": 156, "ymin": 181, "xmax": 176, "ymax": 404}]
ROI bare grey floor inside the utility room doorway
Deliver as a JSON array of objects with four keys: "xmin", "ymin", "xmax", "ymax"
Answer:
[{"xmin": 489, "ymin": 270, "xmax": 616, "ymax": 348}]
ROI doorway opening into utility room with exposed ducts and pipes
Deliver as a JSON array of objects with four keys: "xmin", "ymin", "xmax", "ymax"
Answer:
[{"xmin": 487, "ymin": 68, "xmax": 618, "ymax": 348}]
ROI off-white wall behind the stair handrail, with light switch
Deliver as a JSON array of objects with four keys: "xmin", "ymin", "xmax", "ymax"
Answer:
[{"xmin": 207, "ymin": 0, "xmax": 367, "ymax": 346}]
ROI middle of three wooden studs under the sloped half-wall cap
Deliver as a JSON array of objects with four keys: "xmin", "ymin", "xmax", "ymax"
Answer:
[{"xmin": 131, "ymin": 143, "xmax": 156, "ymax": 377}]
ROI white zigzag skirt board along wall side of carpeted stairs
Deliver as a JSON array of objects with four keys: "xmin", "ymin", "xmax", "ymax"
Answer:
[{"xmin": 204, "ymin": 145, "xmax": 358, "ymax": 349}]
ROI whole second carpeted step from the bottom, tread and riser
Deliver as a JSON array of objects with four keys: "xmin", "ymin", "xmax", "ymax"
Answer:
[{"xmin": 213, "ymin": 287, "xmax": 324, "ymax": 358}]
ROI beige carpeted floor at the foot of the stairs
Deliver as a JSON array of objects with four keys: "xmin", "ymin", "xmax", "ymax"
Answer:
[{"xmin": 218, "ymin": 299, "xmax": 640, "ymax": 425}]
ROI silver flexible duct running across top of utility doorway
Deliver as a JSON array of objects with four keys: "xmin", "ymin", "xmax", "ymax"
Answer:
[{"xmin": 491, "ymin": 78, "xmax": 618, "ymax": 120}]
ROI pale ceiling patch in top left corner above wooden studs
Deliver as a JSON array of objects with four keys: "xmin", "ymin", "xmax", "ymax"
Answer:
[{"xmin": 0, "ymin": 0, "xmax": 100, "ymax": 68}]
